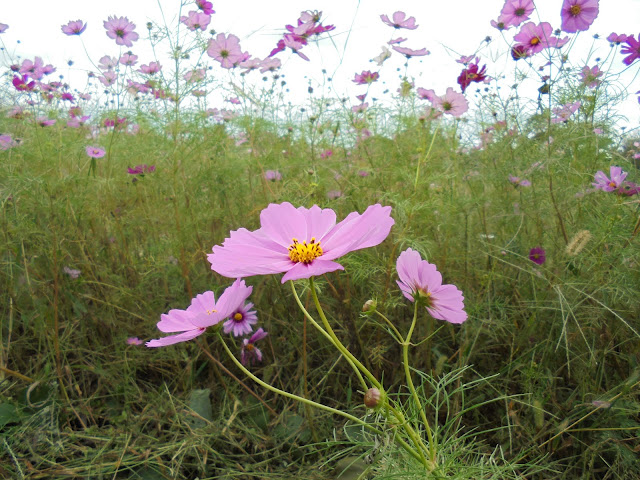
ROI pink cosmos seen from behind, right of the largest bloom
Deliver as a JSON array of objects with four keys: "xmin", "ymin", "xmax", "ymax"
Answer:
[{"xmin": 396, "ymin": 248, "xmax": 467, "ymax": 323}]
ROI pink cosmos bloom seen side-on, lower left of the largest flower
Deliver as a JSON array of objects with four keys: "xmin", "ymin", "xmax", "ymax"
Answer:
[{"xmin": 147, "ymin": 279, "xmax": 253, "ymax": 347}]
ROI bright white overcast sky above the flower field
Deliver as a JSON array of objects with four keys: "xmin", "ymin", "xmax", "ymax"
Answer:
[{"xmin": 0, "ymin": 0, "xmax": 640, "ymax": 128}]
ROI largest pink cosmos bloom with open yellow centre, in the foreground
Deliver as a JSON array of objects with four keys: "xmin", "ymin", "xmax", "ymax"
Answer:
[{"xmin": 208, "ymin": 202, "xmax": 394, "ymax": 283}]
